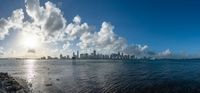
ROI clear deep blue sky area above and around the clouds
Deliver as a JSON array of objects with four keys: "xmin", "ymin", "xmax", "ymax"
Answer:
[{"xmin": 0, "ymin": 0, "xmax": 200, "ymax": 57}]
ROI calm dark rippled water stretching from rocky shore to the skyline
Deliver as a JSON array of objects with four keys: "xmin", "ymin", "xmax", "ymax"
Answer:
[{"xmin": 0, "ymin": 60, "xmax": 200, "ymax": 93}]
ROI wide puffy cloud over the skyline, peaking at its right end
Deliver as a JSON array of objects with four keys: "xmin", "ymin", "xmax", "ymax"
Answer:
[{"xmin": 77, "ymin": 22, "xmax": 126, "ymax": 53}]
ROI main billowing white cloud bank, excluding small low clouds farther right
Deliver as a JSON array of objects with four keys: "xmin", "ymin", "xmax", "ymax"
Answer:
[{"xmin": 0, "ymin": 0, "xmax": 130, "ymax": 55}]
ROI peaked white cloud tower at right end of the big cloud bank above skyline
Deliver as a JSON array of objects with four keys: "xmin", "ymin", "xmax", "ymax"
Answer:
[{"xmin": 95, "ymin": 22, "xmax": 126, "ymax": 52}]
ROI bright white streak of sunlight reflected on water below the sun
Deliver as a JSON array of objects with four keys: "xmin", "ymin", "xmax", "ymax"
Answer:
[{"xmin": 25, "ymin": 60, "xmax": 36, "ymax": 82}]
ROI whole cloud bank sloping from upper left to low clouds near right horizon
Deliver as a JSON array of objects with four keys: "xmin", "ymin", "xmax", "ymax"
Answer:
[{"xmin": 0, "ymin": 0, "xmax": 180, "ymax": 57}]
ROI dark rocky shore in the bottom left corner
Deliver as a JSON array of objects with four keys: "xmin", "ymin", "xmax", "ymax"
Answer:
[{"xmin": 0, "ymin": 72, "xmax": 30, "ymax": 93}]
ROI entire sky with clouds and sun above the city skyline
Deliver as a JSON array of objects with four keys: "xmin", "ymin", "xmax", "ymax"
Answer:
[{"xmin": 0, "ymin": 0, "xmax": 200, "ymax": 57}]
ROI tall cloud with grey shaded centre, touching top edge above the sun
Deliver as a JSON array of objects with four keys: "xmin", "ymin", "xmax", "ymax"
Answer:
[{"xmin": 25, "ymin": 0, "xmax": 66, "ymax": 41}]
